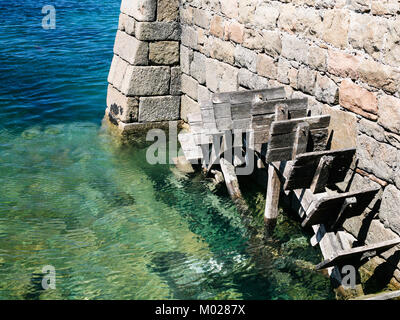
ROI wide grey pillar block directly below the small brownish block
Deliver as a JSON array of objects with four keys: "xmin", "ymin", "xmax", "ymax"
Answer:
[{"xmin": 121, "ymin": 66, "xmax": 171, "ymax": 96}]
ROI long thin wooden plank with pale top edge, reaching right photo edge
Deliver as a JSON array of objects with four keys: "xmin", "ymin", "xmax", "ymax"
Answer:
[{"xmin": 316, "ymin": 238, "xmax": 400, "ymax": 270}]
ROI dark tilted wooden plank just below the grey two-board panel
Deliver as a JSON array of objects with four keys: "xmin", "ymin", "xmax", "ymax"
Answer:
[{"xmin": 284, "ymin": 148, "xmax": 356, "ymax": 190}]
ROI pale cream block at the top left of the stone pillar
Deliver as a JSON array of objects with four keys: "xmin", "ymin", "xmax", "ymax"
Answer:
[{"xmin": 121, "ymin": 0, "xmax": 157, "ymax": 21}]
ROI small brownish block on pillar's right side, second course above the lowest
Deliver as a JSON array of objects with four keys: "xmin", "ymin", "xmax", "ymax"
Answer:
[{"xmin": 149, "ymin": 41, "xmax": 179, "ymax": 65}]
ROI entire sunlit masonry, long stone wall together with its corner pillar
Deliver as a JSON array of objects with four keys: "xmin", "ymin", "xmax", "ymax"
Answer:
[{"xmin": 108, "ymin": 0, "xmax": 400, "ymax": 286}]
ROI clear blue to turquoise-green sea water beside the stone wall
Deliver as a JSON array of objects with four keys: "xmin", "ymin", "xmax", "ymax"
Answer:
[{"xmin": 0, "ymin": 0, "xmax": 333, "ymax": 299}]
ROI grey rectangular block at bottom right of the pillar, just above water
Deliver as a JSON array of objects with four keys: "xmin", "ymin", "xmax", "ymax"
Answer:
[{"xmin": 139, "ymin": 96, "xmax": 181, "ymax": 122}]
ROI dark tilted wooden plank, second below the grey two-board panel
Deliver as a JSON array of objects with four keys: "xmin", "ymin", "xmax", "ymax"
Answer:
[{"xmin": 301, "ymin": 188, "xmax": 380, "ymax": 227}]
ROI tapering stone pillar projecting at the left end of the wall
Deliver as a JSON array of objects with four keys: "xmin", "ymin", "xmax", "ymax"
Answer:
[{"xmin": 106, "ymin": 0, "xmax": 181, "ymax": 131}]
